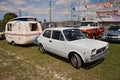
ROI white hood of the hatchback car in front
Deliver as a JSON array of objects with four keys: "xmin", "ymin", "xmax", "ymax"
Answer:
[{"xmin": 70, "ymin": 39, "xmax": 108, "ymax": 49}]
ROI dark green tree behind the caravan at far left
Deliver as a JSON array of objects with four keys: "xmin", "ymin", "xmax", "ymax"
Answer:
[{"xmin": 2, "ymin": 13, "xmax": 17, "ymax": 27}]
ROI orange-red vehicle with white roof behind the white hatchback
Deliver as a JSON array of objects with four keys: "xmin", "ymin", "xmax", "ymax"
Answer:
[{"xmin": 80, "ymin": 21, "xmax": 104, "ymax": 39}]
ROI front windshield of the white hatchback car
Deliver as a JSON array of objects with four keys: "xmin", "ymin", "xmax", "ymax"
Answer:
[{"xmin": 63, "ymin": 29, "xmax": 85, "ymax": 41}]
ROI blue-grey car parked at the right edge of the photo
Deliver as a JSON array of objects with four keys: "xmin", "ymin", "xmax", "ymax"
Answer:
[{"xmin": 102, "ymin": 26, "xmax": 120, "ymax": 42}]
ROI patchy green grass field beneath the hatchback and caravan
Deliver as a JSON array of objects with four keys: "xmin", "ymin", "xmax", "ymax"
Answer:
[{"xmin": 0, "ymin": 40, "xmax": 120, "ymax": 80}]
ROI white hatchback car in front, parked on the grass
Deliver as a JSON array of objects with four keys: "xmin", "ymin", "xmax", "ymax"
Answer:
[{"xmin": 38, "ymin": 27, "xmax": 109, "ymax": 68}]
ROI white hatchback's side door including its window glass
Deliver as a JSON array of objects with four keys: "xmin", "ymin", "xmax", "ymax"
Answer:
[{"xmin": 49, "ymin": 30, "xmax": 67, "ymax": 57}]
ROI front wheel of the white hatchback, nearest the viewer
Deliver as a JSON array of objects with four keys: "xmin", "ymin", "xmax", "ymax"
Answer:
[{"xmin": 70, "ymin": 54, "xmax": 82, "ymax": 69}]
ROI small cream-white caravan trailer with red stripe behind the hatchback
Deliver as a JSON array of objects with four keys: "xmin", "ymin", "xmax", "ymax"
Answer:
[{"xmin": 5, "ymin": 16, "xmax": 42, "ymax": 45}]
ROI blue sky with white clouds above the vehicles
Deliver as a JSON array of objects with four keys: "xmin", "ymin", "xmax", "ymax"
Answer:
[{"xmin": 0, "ymin": 0, "xmax": 116, "ymax": 21}]
